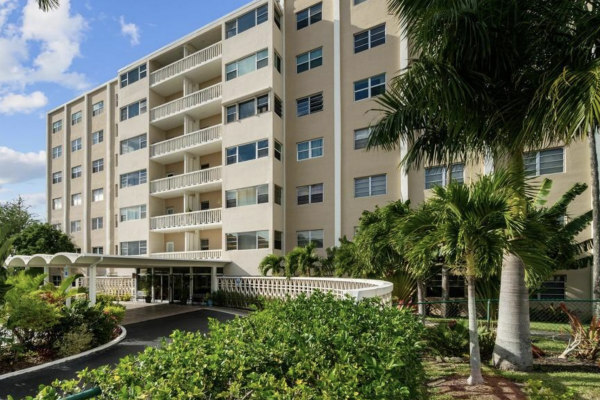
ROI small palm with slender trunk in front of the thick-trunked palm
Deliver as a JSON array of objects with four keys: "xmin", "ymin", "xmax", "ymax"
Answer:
[{"xmin": 403, "ymin": 173, "xmax": 520, "ymax": 385}]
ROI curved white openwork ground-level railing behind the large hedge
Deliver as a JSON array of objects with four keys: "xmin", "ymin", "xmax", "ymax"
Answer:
[{"xmin": 218, "ymin": 276, "xmax": 394, "ymax": 304}]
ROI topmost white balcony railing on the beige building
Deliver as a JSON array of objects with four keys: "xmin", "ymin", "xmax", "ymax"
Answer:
[{"xmin": 150, "ymin": 42, "xmax": 222, "ymax": 96}]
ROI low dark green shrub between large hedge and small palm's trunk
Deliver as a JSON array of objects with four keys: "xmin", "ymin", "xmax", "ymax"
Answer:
[{"xmin": 425, "ymin": 321, "xmax": 469, "ymax": 357}]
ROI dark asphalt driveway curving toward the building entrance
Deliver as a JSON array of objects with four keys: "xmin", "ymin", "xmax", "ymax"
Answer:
[{"xmin": 0, "ymin": 310, "xmax": 234, "ymax": 399}]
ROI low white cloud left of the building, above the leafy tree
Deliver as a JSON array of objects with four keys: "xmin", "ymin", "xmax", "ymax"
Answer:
[{"xmin": 0, "ymin": 146, "xmax": 46, "ymax": 185}]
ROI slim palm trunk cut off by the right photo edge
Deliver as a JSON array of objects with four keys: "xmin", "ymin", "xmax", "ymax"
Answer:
[{"xmin": 588, "ymin": 126, "xmax": 600, "ymax": 318}]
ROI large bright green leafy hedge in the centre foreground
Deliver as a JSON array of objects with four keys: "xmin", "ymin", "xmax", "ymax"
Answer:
[{"xmin": 32, "ymin": 293, "xmax": 424, "ymax": 400}]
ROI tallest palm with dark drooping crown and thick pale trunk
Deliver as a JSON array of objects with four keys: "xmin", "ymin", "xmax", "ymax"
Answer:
[{"xmin": 368, "ymin": 0, "xmax": 568, "ymax": 369}]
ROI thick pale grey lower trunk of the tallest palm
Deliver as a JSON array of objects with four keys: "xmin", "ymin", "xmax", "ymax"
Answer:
[{"xmin": 493, "ymin": 253, "xmax": 533, "ymax": 371}]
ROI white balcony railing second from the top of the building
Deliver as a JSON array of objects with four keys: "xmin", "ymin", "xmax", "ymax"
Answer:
[{"xmin": 150, "ymin": 83, "xmax": 221, "ymax": 129}]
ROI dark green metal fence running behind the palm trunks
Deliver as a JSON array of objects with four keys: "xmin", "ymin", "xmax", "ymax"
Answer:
[{"xmin": 414, "ymin": 299, "xmax": 600, "ymax": 330}]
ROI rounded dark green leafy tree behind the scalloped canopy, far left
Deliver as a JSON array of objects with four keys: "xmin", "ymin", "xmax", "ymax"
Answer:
[{"xmin": 13, "ymin": 222, "xmax": 75, "ymax": 255}]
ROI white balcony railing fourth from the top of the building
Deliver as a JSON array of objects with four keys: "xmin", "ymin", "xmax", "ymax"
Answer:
[{"xmin": 150, "ymin": 167, "xmax": 222, "ymax": 199}]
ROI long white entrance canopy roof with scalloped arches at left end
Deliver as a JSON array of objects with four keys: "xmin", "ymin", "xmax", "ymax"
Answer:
[{"xmin": 6, "ymin": 253, "xmax": 229, "ymax": 268}]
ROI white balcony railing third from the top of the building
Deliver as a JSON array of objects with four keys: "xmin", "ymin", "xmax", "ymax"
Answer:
[{"xmin": 150, "ymin": 125, "xmax": 223, "ymax": 163}]
